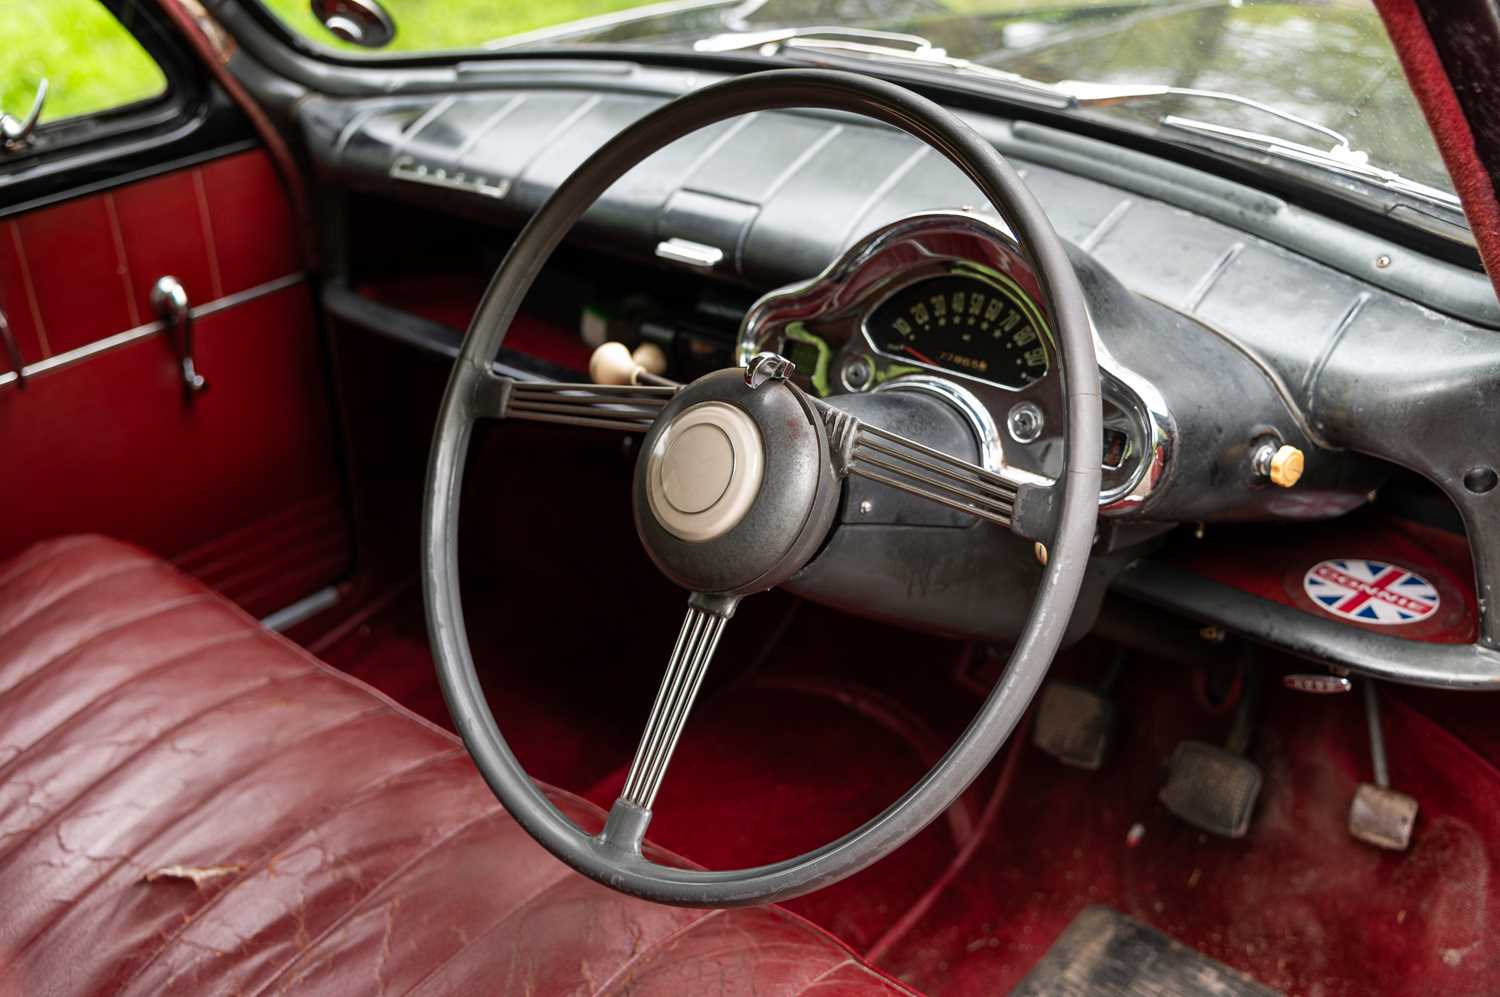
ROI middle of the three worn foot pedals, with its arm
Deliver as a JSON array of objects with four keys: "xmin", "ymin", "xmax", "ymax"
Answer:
[{"xmin": 1157, "ymin": 664, "xmax": 1265, "ymax": 838}]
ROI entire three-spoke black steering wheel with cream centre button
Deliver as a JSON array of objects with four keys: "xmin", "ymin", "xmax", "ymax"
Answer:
[{"xmin": 422, "ymin": 69, "xmax": 1103, "ymax": 907}]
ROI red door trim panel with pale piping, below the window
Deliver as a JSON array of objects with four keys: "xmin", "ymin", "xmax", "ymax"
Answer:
[{"xmin": 0, "ymin": 151, "xmax": 350, "ymax": 615}]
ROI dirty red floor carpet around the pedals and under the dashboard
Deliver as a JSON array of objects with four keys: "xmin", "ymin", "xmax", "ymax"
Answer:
[{"xmin": 301, "ymin": 589, "xmax": 1500, "ymax": 997}]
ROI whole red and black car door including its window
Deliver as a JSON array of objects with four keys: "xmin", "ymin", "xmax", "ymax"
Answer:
[{"xmin": 0, "ymin": 0, "xmax": 351, "ymax": 615}]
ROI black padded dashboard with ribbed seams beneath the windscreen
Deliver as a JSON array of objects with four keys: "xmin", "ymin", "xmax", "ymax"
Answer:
[{"xmin": 276, "ymin": 60, "xmax": 1500, "ymax": 680}]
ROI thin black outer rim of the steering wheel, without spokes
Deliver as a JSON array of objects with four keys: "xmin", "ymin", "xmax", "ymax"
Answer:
[{"xmin": 422, "ymin": 69, "xmax": 1103, "ymax": 907}]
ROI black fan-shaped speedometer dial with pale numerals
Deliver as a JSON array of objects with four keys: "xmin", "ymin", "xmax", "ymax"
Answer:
[{"xmin": 864, "ymin": 271, "xmax": 1050, "ymax": 388}]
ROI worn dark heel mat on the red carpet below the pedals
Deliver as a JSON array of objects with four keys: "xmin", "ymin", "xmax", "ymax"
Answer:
[{"xmin": 1011, "ymin": 906, "xmax": 1278, "ymax": 997}]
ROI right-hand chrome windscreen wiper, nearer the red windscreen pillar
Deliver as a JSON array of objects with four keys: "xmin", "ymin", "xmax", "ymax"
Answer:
[{"xmin": 1056, "ymin": 79, "xmax": 1461, "ymax": 208}]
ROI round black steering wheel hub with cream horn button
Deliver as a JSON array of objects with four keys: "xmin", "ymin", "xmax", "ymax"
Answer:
[{"xmin": 635, "ymin": 370, "xmax": 839, "ymax": 595}]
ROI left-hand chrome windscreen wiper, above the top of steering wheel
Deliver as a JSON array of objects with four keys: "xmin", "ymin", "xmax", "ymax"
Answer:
[{"xmin": 693, "ymin": 27, "xmax": 1077, "ymax": 106}]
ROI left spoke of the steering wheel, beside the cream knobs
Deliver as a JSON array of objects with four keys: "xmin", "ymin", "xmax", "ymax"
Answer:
[{"xmin": 477, "ymin": 375, "xmax": 678, "ymax": 433}]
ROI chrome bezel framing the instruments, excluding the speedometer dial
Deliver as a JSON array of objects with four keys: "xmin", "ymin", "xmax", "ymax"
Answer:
[{"xmin": 738, "ymin": 208, "xmax": 1175, "ymax": 516}]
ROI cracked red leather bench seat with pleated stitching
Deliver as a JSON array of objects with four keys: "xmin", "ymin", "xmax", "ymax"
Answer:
[{"xmin": 0, "ymin": 537, "xmax": 908, "ymax": 994}]
